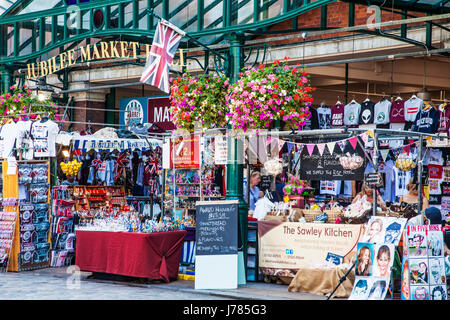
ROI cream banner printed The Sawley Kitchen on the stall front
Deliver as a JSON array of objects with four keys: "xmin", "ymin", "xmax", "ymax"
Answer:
[{"xmin": 258, "ymin": 221, "xmax": 362, "ymax": 276}]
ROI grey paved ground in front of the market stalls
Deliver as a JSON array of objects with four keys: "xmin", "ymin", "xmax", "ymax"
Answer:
[{"xmin": 0, "ymin": 268, "xmax": 325, "ymax": 300}]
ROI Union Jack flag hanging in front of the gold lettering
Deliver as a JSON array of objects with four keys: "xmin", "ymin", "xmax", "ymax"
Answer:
[{"xmin": 140, "ymin": 19, "xmax": 185, "ymax": 93}]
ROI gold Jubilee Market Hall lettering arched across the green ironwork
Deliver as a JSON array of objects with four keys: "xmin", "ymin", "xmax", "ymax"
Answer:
[{"xmin": 27, "ymin": 41, "xmax": 185, "ymax": 79}]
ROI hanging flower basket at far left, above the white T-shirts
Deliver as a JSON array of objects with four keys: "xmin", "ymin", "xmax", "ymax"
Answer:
[{"xmin": 0, "ymin": 85, "xmax": 60, "ymax": 123}]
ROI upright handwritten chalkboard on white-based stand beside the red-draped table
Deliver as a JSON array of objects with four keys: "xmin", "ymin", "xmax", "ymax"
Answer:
[{"xmin": 195, "ymin": 201, "xmax": 238, "ymax": 255}]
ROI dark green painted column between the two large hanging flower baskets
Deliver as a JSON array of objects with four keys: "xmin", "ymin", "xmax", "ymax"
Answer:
[{"xmin": 226, "ymin": 33, "xmax": 248, "ymax": 273}]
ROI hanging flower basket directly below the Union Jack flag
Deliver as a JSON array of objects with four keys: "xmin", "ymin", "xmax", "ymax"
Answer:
[{"xmin": 170, "ymin": 74, "xmax": 229, "ymax": 132}]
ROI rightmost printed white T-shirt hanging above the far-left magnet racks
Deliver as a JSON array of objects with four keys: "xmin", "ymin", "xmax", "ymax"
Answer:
[{"xmin": 31, "ymin": 120, "xmax": 59, "ymax": 157}]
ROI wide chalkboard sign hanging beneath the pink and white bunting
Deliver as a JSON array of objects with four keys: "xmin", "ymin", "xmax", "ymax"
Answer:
[{"xmin": 300, "ymin": 136, "xmax": 366, "ymax": 181}]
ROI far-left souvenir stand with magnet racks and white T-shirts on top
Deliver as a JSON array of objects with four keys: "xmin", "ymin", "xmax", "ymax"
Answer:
[{"xmin": 0, "ymin": 109, "xmax": 59, "ymax": 271}]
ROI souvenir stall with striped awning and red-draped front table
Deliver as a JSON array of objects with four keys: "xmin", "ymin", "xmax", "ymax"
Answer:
[{"xmin": 53, "ymin": 128, "xmax": 190, "ymax": 282}]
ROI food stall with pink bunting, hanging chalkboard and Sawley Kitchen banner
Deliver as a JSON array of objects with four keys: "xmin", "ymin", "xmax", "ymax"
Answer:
[{"xmin": 249, "ymin": 124, "xmax": 444, "ymax": 297}]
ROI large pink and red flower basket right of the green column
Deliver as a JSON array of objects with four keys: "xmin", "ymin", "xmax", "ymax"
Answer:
[{"xmin": 228, "ymin": 58, "xmax": 315, "ymax": 132}]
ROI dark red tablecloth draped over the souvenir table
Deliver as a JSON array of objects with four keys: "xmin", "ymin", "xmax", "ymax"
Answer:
[{"xmin": 75, "ymin": 231, "xmax": 186, "ymax": 282}]
